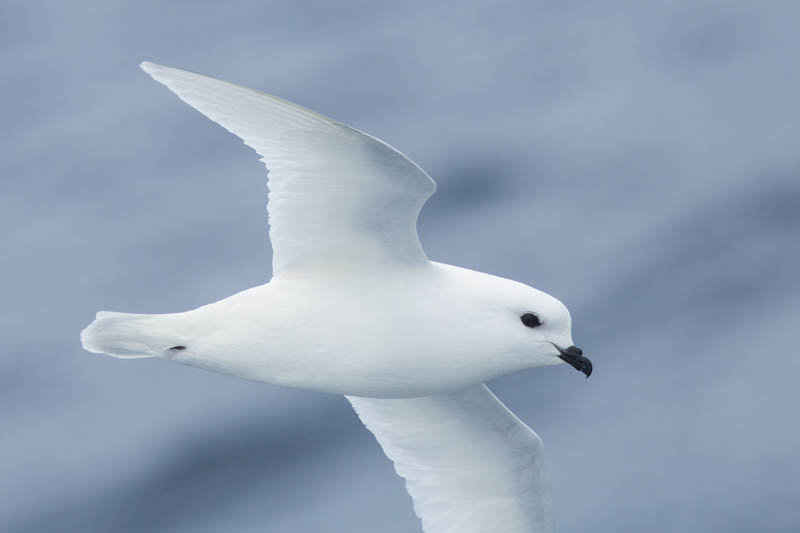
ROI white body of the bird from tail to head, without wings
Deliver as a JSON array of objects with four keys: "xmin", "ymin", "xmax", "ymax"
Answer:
[{"xmin": 83, "ymin": 262, "xmax": 572, "ymax": 398}]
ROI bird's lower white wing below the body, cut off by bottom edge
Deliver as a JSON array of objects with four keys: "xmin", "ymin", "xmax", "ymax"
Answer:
[{"xmin": 348, "ymin": 385, "xmax": 553, "ymax": 533}]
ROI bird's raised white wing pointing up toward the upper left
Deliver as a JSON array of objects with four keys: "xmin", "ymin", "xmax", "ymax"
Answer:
[{"xmin": 142, "ymin": 63, "xmax": 436, "ymax": 275}]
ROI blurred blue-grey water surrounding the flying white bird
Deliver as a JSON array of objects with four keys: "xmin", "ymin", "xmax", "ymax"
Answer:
[{"xmin": 0, "ymin": 0, "xmax": 800, "ymax": 533}]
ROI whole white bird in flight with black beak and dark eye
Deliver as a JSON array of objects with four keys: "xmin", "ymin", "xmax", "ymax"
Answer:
[{"xmin": 81, "ymin": 62, "xmax": 592, "ymax": 533}]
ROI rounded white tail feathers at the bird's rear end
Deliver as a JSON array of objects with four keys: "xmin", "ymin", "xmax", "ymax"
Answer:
[{"xmin": 81, "ymin": 311, "xmax": 185, "ymax": 358}]
